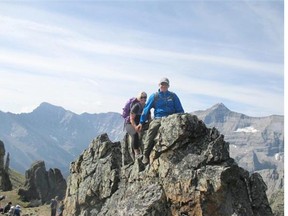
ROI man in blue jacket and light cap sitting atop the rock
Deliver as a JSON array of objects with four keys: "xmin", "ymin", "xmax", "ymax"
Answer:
[{"xmin": 137, "ymin": 77, "xmax": 184, "ymax": 164}]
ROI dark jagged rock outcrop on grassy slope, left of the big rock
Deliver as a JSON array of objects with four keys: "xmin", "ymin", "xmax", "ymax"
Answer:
[{"xmin": 18, "ymin": 161, "xmax": 67, "ymax": 204}]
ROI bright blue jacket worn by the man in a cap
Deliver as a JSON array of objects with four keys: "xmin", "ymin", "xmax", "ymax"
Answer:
[{"xmin": 140, "ymin": 90, "xmax": 184, "ymax": 124}]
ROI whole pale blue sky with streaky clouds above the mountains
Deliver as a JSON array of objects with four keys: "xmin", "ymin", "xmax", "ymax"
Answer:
[{"xmin": 0, "ymin": 0, "xmax": 284, "ymax": 116}]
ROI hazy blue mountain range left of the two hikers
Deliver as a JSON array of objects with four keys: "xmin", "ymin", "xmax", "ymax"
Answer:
[{"xmin": 0, "ymin": 103, "xmax": 124, "ymax": 175}]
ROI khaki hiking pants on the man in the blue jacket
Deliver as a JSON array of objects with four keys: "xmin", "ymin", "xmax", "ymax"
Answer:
[{"xmin": 143, "ymin": 119, "xmax": 161, "ymax": 157}]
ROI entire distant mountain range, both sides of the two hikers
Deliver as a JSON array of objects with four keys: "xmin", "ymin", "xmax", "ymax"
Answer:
[{"xmin": 0, "ymin": 103, "xmax": 284, "ymax": 198}]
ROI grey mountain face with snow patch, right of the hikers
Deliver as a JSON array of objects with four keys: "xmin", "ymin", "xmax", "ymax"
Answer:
[{"xmin": 193, "ymin": 104, "xmax": 284, "ymax": 197}]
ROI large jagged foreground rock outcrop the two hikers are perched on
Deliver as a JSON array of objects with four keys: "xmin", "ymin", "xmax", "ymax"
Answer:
[{"xmin": 64, "ymin": 114, "xmax": 272, "ymax": 216}]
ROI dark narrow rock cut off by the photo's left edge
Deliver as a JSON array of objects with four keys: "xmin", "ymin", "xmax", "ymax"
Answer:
[{"xmin": 0, "ymin": 140, "xmax": 12, "ymax": 191}]
